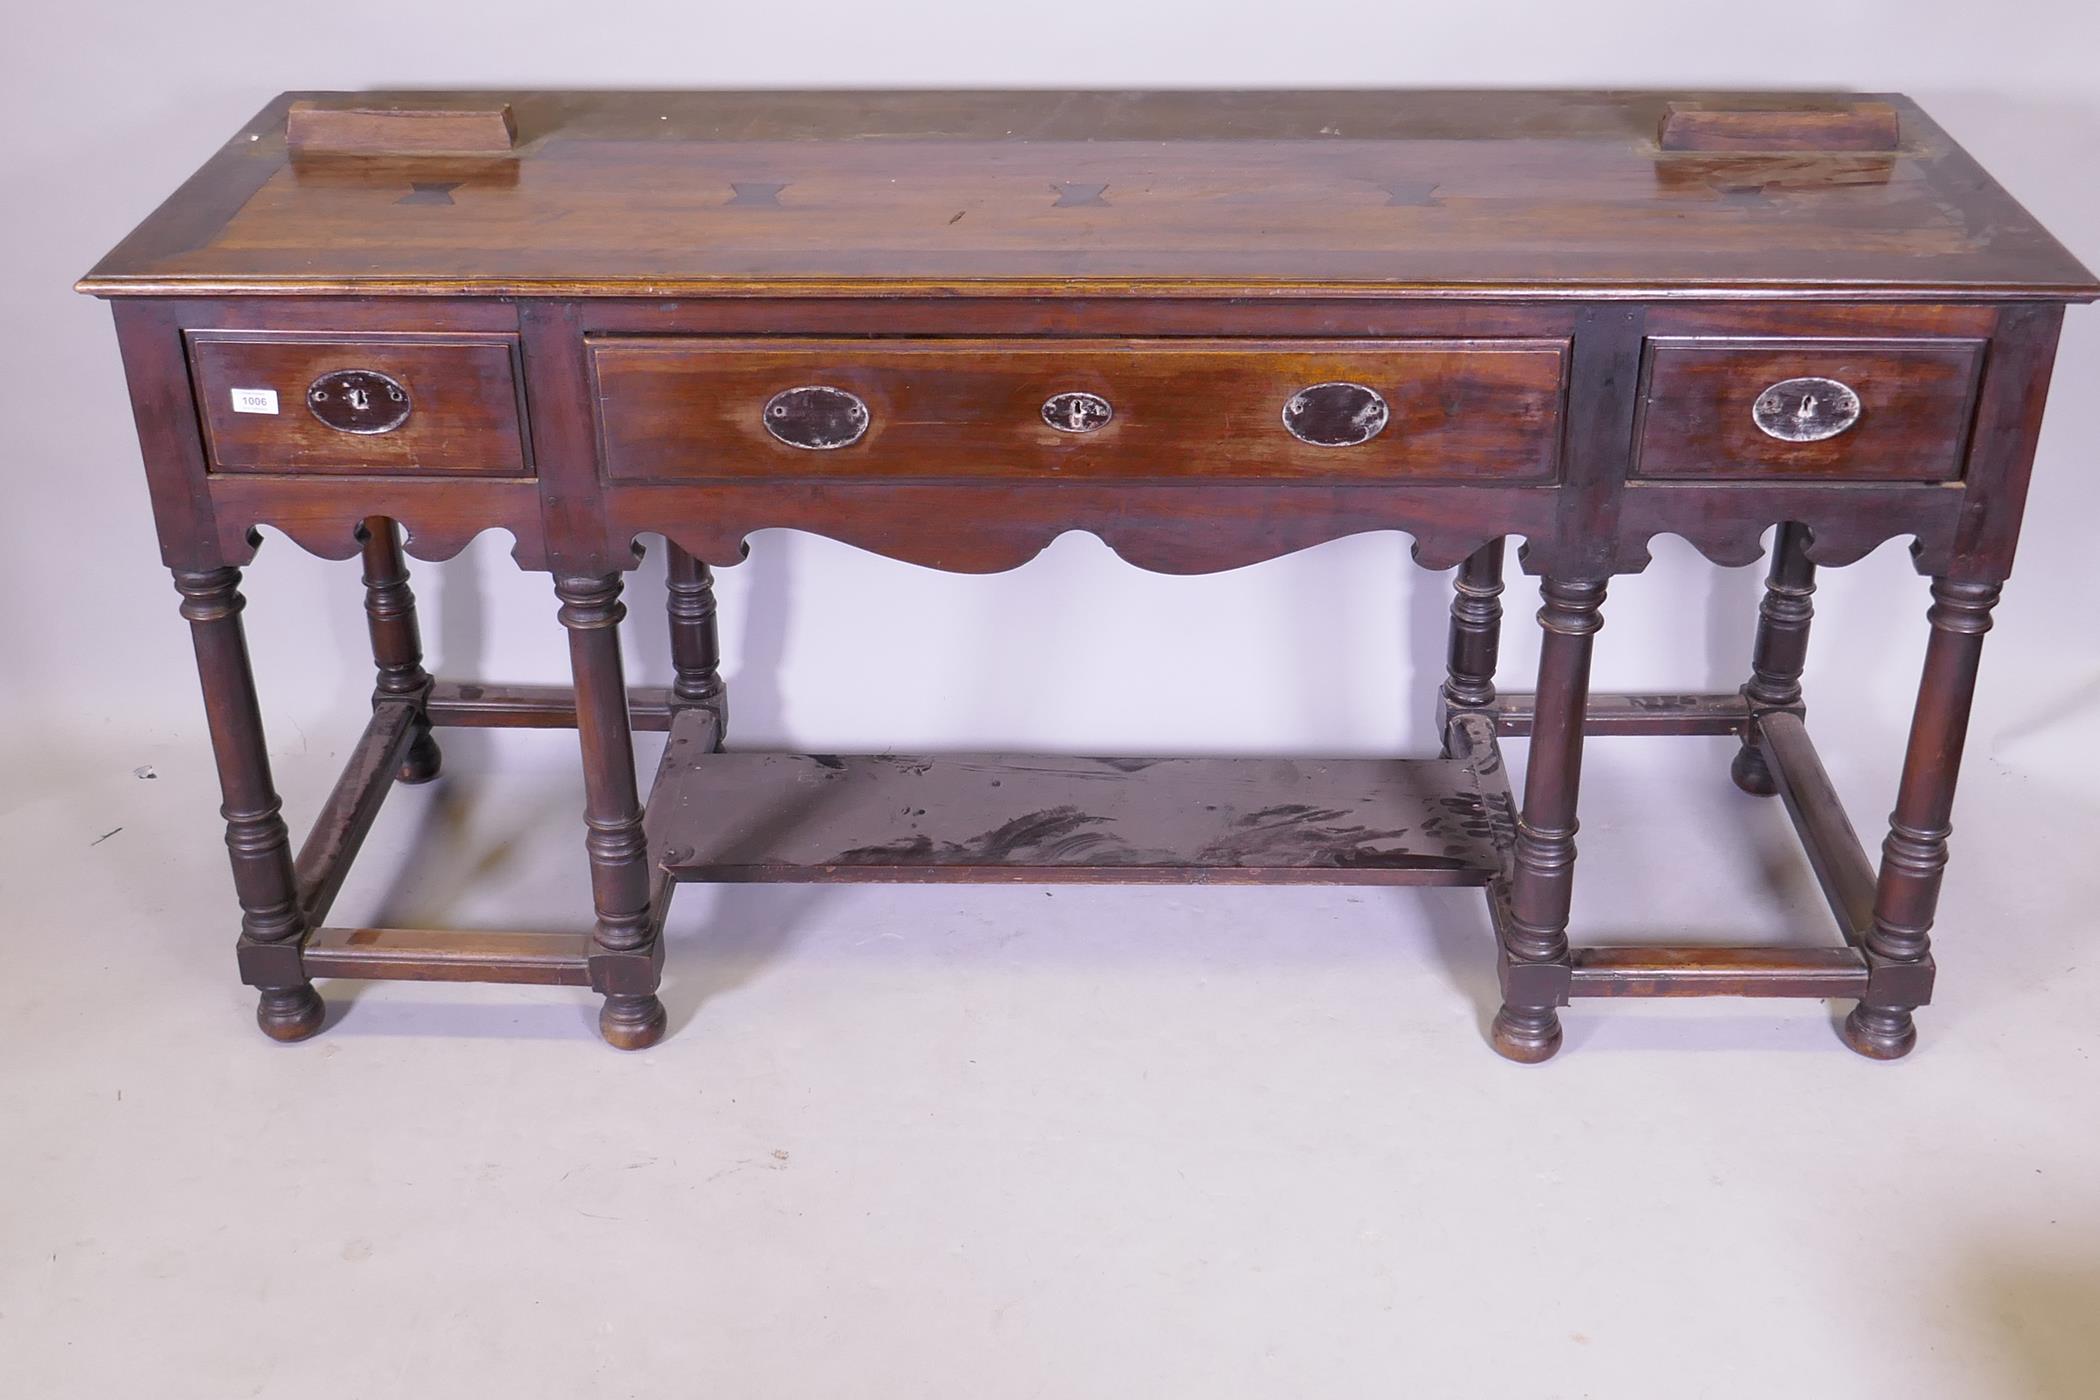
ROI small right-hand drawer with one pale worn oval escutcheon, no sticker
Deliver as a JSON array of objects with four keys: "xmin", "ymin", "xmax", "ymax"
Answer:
[{"xmin": 1634, "ymin": 336, "xmax": 1985, "ymax": 483}]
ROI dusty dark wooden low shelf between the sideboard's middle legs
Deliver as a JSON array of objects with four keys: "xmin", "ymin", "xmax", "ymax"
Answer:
[{"xmin": 649, "ymin": 712, "xmax": 1510, "ymax": 886}]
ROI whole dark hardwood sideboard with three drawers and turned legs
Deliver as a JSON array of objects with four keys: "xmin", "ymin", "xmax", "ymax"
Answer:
[{"xmin": 80, "ymin": 92, "xmax": 2100, "ymax": 1060}]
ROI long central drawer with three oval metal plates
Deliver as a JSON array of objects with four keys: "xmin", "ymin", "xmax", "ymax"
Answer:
[{"xmin": 590, "ymin": 336, "xmax": 1567, "ymax": 483}]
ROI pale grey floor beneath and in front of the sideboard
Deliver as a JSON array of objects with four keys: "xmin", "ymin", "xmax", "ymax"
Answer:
[{"xmin": 0, "ymin": 717, "xmax": 2100, "ymax": 1400}]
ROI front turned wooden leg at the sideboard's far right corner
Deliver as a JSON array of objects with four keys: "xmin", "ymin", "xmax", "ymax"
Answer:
[{"xmin": 1844, "ymin": 579, "xmax": 1999, "ymax": 1060}]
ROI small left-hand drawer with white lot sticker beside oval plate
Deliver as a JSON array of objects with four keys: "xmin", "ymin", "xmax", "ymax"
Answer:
[{"xmin": 189, "ymin": 332, "xmax": 531, "ymax": 476}]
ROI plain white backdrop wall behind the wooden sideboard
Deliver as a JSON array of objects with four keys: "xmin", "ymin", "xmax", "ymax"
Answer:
[{"xmin": 0, "ymin": 0, "xmax": 2100, "ymax": 789}]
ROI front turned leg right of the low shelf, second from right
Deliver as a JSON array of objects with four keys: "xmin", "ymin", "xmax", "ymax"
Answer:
[{"xmin": 1491, "ymin": 579, "xmax": 1604, "ymax": 1064}]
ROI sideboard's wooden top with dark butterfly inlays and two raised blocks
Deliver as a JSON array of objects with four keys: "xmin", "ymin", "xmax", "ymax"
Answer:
[{"xmin": 82, "ymin": 92, "xmax": 2100, "ymax": 302}]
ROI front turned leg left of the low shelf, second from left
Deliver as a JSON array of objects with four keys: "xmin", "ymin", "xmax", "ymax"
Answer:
[{"xmin": 554, "ymin": 573, "xmax": 666, "ymax": 1049}]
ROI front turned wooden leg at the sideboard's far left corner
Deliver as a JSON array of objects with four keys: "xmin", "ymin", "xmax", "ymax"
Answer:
[{"xmin": 174, "ymin": 569, "xmax": 323, "ymax": 1041}]
